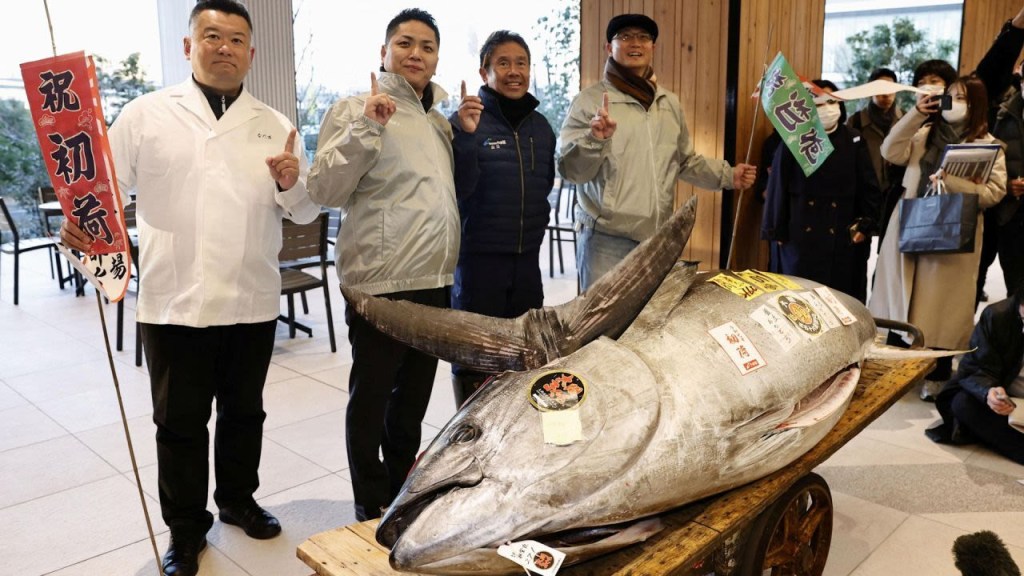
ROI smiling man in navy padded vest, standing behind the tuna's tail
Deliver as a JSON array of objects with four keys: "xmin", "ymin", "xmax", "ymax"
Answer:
[{"xmin": 450, "ymin": 30, "xmax": 555, "ymax": 407}]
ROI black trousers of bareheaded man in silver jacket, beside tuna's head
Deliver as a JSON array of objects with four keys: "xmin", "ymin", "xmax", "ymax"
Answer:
[{"xmin": 345, "ymin": 288, "xmax": 447, "ymax": 521}]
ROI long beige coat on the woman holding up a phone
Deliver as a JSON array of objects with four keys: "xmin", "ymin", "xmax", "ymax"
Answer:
[{"xmin": 868, "ymin": 108, "xmax": 1007, "ymax": 349}]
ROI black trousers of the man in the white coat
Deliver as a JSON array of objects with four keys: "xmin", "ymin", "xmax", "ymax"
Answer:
[{"xmin": 140, "ymin": 320, "xmax": 276, "ymax": 534}]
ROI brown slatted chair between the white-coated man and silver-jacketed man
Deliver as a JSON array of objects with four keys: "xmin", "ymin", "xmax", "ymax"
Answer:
[{"xmin": 278, "ymin": 212, "xmax": 338, "ymax": 352}]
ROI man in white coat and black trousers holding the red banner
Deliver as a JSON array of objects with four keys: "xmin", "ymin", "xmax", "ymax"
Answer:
[{"xmin": 61, "ymin": 0, "xmax": 319, "ymax": 576}]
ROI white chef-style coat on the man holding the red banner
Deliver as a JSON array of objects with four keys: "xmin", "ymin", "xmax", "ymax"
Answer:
[{"xmin": 110, "ymin": 79, "xmax": 319, "ymax": 328}]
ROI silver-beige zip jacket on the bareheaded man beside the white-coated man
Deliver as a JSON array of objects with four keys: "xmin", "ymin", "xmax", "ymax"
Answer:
[{"xmin": 308, "ymin": 72, "xmax": 459, "ymax": 294}]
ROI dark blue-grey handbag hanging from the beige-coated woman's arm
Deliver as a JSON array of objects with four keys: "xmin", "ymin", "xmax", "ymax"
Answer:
[{"xmin": 899, "ymin": 178, "xmax": 978, "ymax": 254}]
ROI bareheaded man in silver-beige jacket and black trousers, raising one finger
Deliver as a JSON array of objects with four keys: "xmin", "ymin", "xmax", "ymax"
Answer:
[{"xmin": 308, "ymin": 9, "xmax": 460, "ymax": 521}]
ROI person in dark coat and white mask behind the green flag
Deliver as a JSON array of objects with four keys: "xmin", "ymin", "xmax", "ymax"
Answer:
[{"xmin": 761, "ymin": 80, "xmax": 881, "ymax": 301}]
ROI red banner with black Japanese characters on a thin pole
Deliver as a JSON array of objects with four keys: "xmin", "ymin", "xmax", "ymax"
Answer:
[{"xmin": 22, "ymin": 52, "xmax": 131, "ymax": 300}]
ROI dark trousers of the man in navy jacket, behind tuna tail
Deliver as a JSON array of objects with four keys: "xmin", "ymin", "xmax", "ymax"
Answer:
[{"xmin": 452, "ymin": 247, "xmax": 544, "ymax": 408}]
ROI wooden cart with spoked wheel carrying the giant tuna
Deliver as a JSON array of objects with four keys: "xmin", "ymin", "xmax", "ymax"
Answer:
[{"xmin": 297, "ymin": 360, "xmax": 934, "ymax": 576}]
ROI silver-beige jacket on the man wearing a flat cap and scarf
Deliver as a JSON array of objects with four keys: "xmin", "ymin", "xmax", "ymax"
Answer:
[{"xmin": 558, "ymin": 80, "xmax": 732, "ymax": 242}]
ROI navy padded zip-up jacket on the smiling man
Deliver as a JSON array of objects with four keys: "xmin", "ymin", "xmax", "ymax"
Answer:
[{"xmin": 450, "ymin": 87, "xmax": 555, "ymax": 254}]
